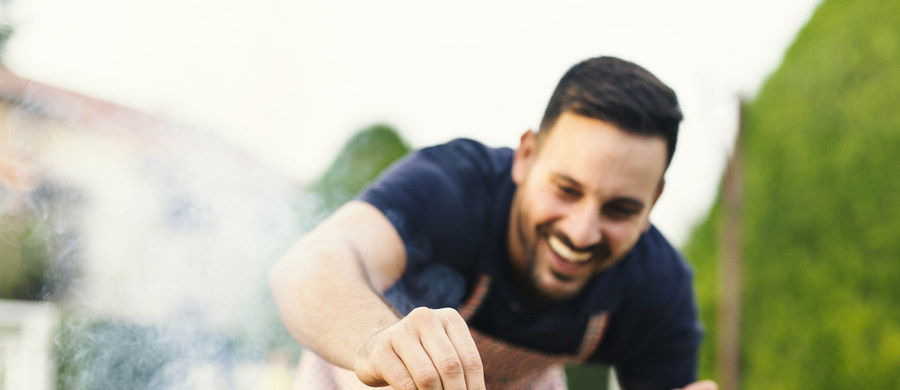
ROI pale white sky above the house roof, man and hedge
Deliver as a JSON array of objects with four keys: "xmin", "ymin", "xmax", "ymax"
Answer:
[{"xmin": 4, "ymin": 0, "xmax": 818, "ymax": 245}]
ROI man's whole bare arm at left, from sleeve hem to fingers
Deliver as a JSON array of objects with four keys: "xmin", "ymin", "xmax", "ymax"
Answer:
[{"xmin": 270, "ymin": 201, "xmax": 484, "ymax": 389}]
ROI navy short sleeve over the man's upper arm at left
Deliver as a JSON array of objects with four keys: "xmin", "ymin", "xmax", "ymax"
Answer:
[{"xmin": 358, "ymin": 139, "xmax": 512, "ymax": 276}]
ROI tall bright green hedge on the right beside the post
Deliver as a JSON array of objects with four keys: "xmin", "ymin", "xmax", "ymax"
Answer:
[{"xmin": 687, "ymin": 0, "xmax": 900, "ymax": 389}]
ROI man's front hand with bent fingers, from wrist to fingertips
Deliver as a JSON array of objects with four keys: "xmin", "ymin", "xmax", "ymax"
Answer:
[{"xmin": 353, "ymin": 307, "xmax": 485, "ymax": 390}]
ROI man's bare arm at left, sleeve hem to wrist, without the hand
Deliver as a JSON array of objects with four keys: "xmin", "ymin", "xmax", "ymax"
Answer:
[{"xmin": 269, "ymin": 203, "xmax": 405, "ymax": 369}]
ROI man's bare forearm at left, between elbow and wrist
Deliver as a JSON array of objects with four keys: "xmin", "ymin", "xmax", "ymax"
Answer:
[{"xmin": 270, "ymin": 239, "xmax": 399, "ymax": 369}]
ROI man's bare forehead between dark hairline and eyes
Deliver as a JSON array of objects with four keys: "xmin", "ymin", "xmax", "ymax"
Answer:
[{"xmin": 537, "ymin": 112, "xmax": 666, "ymax": 192}]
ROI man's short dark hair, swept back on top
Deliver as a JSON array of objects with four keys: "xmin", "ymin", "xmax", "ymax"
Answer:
[{"xmin": 540, "ymin": 57, "xmax": 683, "ymax": 167}]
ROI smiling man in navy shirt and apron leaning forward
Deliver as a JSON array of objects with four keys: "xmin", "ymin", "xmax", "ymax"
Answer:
[{"xmin": 271, "ymin": 57, "xmax": 715, "ymax": 389}]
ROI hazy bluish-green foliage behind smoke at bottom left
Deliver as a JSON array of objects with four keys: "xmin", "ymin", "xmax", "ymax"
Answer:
[{"xmin": 54, "ymin": 313, "xmax": 242, "ymax": 390}]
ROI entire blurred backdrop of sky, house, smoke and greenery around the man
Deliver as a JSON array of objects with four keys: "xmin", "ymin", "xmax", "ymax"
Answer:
[{"xmin": 0, "ymin": 0, "xmax": 900, "ymax": 389}]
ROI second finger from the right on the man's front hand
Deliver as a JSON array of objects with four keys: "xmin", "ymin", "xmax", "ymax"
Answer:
[{"xmin": 419, "ymin": 311, "xmax": 466, "ymax": 390}]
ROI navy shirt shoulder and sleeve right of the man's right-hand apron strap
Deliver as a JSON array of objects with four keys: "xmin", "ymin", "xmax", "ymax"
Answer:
[{"xmin": 606, "ymin": 227, "xmax": 703, "ymax": 388}]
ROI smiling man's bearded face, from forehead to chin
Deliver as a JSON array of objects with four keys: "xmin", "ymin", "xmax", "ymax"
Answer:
[{"xmin": 508, "ymin": 112, "xmax": 666, "ymax": 301}]
